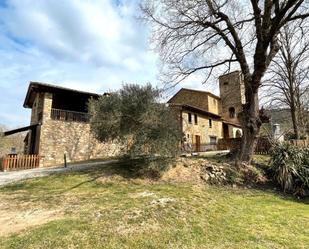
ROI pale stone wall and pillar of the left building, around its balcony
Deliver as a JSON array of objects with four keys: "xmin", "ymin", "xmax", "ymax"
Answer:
[{"xmin": 39, "ymin": 93, "xmax": 121, "ymax": 166}]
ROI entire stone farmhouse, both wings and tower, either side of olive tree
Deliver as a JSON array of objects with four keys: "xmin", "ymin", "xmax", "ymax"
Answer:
[{"xmin": 5, "ymin": 71, "xmax": 244, "ymax": 166}]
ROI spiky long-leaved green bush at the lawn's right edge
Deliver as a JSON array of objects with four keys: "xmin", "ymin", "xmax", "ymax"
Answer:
[{"xmin": 271, "ymin": 143, "xmax": 309, "ymax": 196}]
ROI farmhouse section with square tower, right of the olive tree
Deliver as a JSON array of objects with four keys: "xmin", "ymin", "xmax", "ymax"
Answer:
[{"xmin": 168, "ymin": 71, "xmax": 245, "ymax": 151}]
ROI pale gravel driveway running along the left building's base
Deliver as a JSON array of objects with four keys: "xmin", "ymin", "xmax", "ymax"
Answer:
[{"xmin": 0, "ymin": 160, "xmax": 115, "ymax": 186}]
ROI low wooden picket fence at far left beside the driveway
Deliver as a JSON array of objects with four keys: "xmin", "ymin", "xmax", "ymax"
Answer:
[{"xmin": 0, "ymin": 155, "xmax": 40, "ymax": 171}]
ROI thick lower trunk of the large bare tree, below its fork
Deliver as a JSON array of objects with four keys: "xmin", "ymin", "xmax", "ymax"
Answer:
[{"xmin": 236, "ymin": 89, "xmax": 261, "ymax": 164}]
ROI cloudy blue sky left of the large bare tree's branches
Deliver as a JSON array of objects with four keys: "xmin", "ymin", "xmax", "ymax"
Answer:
[{"xmin": 0, "ymin": 0, "xmax": 217, "ymax": 128}]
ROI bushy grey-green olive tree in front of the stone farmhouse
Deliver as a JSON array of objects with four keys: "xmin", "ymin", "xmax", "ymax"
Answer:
[{"xmin": 89, "ymin": 84, "xmax": 181, "ymax": 156}]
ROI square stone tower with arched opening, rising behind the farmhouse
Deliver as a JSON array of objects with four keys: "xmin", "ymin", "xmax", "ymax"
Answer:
[{"xmin": 219, "ymin": 71, "xmax": 246, "ymax": 123}]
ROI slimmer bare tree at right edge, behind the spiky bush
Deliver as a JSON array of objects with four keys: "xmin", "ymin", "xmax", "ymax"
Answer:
[{"xmin": 263, "ymin": 24, "xmax": 309, "ymax": 139}]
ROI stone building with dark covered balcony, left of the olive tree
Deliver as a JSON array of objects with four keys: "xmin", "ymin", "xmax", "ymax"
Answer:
[{"xmin": 24, "ymin": 82, "xmax": 121, "ymax": 166}]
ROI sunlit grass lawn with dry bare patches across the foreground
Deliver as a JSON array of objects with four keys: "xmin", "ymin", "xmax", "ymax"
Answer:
[{"xmin": 0, "ymin": 160, "xmax": 309, "ymax": 249}]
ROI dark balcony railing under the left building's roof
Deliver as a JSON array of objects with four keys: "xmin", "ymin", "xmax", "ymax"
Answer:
[{"xmin": 50, "ymin": 108, "xmax": 90, "ymax": 123}]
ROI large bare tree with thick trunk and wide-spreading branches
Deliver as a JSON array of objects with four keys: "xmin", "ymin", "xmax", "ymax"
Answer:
[{"xmin": 141, "ymin": 0, "xmax": 309, "ymax": 162}]
